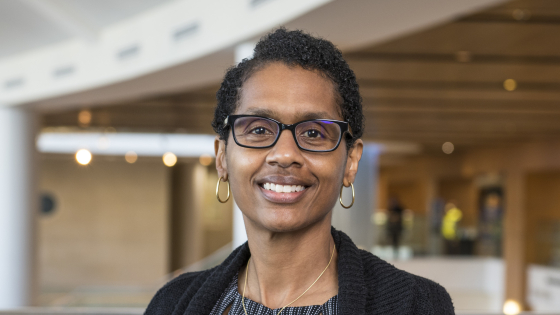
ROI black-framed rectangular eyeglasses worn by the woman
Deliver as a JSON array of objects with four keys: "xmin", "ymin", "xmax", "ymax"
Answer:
[{"xmin": 224, "ymin": 115, "xmax": 352, "ymax": 152}]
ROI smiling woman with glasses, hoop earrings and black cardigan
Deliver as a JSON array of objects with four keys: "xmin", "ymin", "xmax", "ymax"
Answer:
[{"xmin": 146, "ymin": 29, "xmax": 454, "ymax": 315}]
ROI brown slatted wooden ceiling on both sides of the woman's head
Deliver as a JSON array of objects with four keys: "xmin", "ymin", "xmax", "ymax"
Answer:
[{"xmin": 44, "ymin": 0, "xmax": 560, "ymax": 153}]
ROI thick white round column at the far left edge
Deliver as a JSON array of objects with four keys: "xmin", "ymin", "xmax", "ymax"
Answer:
[{"xmin": 0, "ymin": 104, "xmax": 38, "ymax": 309}]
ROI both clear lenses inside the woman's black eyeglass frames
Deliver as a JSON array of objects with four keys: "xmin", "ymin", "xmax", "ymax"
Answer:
[{"xmin": 233, "ymin": 117, "xmax": 341, "ymax": 151}]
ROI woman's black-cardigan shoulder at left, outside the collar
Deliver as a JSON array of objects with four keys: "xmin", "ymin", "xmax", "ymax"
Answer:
[{"xmin": 144, "ymin": 269, "xmax": 212, "ymax": 315}]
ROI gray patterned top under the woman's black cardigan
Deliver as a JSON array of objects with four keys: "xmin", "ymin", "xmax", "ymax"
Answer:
[{"xmin": 210, "ymin": 275, "xmax": 338, "ymax": 315}]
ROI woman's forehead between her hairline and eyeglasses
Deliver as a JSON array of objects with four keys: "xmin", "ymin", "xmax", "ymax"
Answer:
[{"xmin": 236, "ymin": 63, "xmax": 342, "ymax": 124}]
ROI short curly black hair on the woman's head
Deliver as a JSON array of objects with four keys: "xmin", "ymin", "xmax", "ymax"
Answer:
[{"xmin": 212, "ymin": 28, "xmax": 364, "ymax": 149}]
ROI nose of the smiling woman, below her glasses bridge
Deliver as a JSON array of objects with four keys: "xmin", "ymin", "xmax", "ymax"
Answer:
[{"xmin": 266, "ymin": 130, "xmax": 303, "ymax": 168}]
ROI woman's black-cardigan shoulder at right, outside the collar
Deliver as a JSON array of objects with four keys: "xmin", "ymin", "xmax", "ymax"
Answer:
[{"xmin": 360, "ymin": 250, "xmax": 454, "ymax": 315}]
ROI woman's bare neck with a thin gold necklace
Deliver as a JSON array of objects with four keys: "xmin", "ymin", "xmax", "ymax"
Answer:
[{"xmin": 239, "ymin": 215, "xmax": 338, "ymax": 309}]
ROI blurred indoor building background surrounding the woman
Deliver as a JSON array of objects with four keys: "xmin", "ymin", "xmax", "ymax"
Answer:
[{"xmin": 0, "ymin": 0, "xmax": 560, "ymax": 314}]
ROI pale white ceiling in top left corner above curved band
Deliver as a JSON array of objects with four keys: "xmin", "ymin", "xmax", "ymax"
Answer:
[{"xmin": 0, "ymin": 0, "xmax": 172, "ymax": 58}]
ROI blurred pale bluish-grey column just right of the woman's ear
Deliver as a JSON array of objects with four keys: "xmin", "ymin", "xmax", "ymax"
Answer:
[{"xmin": 333, "ymin": 144, "xmax": 379, "ymax": 250}]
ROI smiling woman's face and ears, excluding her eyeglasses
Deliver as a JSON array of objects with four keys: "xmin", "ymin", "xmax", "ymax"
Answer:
[{"xmin": 216, "ymin": 63, "xmax": 362, "ymax": 232}]
